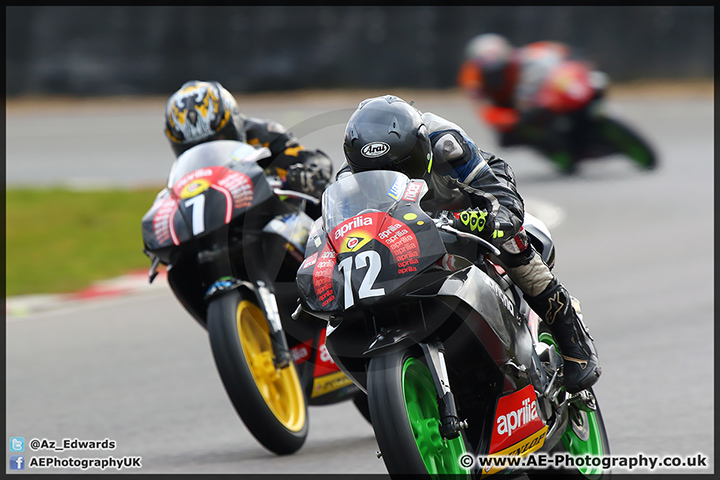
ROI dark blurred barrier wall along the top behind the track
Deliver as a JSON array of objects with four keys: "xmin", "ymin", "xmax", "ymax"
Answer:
[{"xmin": 6, "ymin": 6, "xmax": 714, "ymax": 96}]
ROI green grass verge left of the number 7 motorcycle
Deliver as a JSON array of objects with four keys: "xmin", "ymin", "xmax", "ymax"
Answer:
[{"xmin": 5, "ymin": 187, "xmax": 161, "ymax": 296}]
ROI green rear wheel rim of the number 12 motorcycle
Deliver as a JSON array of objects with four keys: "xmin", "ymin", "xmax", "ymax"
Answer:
[{"xmin": 538, "ymin": 332, "xmax": 603, "ymax": 479}]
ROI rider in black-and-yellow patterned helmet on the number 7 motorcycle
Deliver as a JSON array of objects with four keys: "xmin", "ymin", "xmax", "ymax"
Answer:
[{"xmin": 165, "ymin": 80, "xmax": 332, "ymax": 198}]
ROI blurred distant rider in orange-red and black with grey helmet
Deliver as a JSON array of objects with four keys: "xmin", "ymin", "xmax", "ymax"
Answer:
[{"xmin": 457, "ymin": 33, "xmax": 620, "ymax": 173}]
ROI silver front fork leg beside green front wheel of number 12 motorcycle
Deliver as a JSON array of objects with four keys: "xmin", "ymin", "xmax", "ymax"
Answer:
[{"xmin": 420, "ymin": 341, "xmax": 468, "ymax": 440}]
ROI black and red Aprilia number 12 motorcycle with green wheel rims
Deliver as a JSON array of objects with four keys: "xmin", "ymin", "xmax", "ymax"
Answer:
[{"xmin": 294, "ymin": 171, "xmax": 610, "ymax": 478}]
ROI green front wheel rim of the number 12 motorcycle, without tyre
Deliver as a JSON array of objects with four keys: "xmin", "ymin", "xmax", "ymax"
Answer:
[{"xmin": 402, "ymin": 358, "xmax": 468, "ymax": 476}]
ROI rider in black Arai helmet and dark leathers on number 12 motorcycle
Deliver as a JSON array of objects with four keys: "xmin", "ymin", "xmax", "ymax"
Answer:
[{"xmin": 337, "ymin": 95, "xmax": 601, "ymax": 394}]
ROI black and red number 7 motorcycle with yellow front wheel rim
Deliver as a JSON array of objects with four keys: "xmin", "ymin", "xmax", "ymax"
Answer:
[{"xmin": 142, "ymin": 140, "xmax": 369, "ymax": 454}]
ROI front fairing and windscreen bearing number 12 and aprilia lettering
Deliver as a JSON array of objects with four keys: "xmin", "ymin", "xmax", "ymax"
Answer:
[{"xmin": 297, "ymin": 171, "xmax": 446, "ymax": 313}]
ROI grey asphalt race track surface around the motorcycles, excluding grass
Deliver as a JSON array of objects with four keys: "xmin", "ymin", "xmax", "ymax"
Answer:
[{"xmin": 6, "ymin": 87, "xmax": 715, "ymax": 474}]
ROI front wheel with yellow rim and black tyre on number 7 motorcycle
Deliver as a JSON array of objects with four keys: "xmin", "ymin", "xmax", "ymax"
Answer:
[{"xmin": 207, "ymin": 290, "xmax": 308, "ymax": 455}]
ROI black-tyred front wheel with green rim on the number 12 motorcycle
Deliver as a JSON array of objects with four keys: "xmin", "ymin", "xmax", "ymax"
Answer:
[{"xmin": 368, "ymin": 351, "xmax": 469, "ymax": 479}]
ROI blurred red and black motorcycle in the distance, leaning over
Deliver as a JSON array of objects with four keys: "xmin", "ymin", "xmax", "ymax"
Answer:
[{"xmin": 479, "ymin": 60, "xmax": 658, "ymax": 173}]
